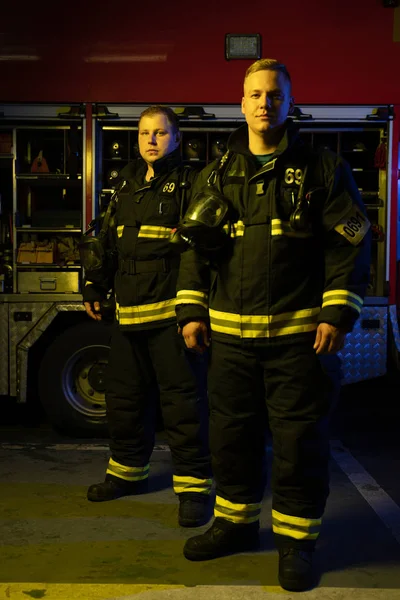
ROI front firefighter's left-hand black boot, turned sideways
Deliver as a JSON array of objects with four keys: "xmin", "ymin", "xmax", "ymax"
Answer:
[{"xmin": 183, "ymin": 517, "xmax": 260, "ymax": 560}]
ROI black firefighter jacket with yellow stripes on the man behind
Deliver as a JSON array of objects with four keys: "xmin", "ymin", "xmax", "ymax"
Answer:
[{"xmin": 83, "ymin": 150, "xmax": 195, "ymax": 330}]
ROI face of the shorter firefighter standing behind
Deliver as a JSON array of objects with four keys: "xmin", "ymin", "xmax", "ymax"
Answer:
[{"xmin": 138, "ymin": 113, "xmax": 180, "ymax": 165}]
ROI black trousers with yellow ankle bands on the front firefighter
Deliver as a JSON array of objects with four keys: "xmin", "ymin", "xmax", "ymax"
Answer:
[{"xmin": 208, "ymin": 339, "xmax": 332, "ymax": 549}]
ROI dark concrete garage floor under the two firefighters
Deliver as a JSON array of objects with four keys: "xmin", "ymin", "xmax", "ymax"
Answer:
[{"xmin": 0, "ymin": 382, "xmax": 400, "ymax": 600}]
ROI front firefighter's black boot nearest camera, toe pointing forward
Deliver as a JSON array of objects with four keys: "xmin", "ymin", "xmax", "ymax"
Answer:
[{"xmin": 279, "ymin": 548, "xmax": 315, "ymax": 592}]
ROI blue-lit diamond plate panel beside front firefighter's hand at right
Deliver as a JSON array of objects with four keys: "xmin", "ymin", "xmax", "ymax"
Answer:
[{"xmin": 338, "ymin": 306, "xmax": 388, "ymax": 385}]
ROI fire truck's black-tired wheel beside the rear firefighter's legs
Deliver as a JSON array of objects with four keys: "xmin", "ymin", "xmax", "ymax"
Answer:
[{"xmin": 39, "ymin": 321, "xmax": 111, "ymax": 437}]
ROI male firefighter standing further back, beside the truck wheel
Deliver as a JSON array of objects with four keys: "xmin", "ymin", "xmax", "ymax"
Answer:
[{"xmin": 83, "ymin": 106, "xmax": 211, "ymax": 527}]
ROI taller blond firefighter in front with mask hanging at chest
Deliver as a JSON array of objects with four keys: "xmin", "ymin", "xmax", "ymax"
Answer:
[{"xmin": 176, "ymin": 59, "xmax": 370, "ymax": 591}]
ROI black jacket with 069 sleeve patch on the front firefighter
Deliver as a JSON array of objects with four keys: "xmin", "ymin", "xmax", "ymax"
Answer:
[{"xmin": 176, "ymin": 119, "xmax": 370, "ymax": 343}]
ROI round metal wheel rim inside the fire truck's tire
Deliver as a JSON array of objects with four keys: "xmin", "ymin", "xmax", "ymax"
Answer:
[{"xmin": 62, "ymin": 345, "xmax": 110, "ymax": 422}]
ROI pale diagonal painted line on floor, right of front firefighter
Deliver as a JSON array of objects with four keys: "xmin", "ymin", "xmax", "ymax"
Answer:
[{"xmin": 331, "ymin": 440, "xmax": 400, "ymax": 544}]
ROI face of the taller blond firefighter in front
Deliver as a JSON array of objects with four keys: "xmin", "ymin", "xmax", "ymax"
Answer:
[{"xmin": 242, "ymin": 70, "xmax": 293, "ymax": 135}]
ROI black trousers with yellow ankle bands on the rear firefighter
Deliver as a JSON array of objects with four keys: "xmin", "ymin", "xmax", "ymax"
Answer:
[{"xmin": 106, "ymin": 324, "xmax": 211, "ymax": 494}]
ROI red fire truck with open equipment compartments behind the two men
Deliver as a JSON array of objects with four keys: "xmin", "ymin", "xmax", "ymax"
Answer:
[{"xmin": 0, "ymin": 0, "xmax": 400, "ymax": 435}]
